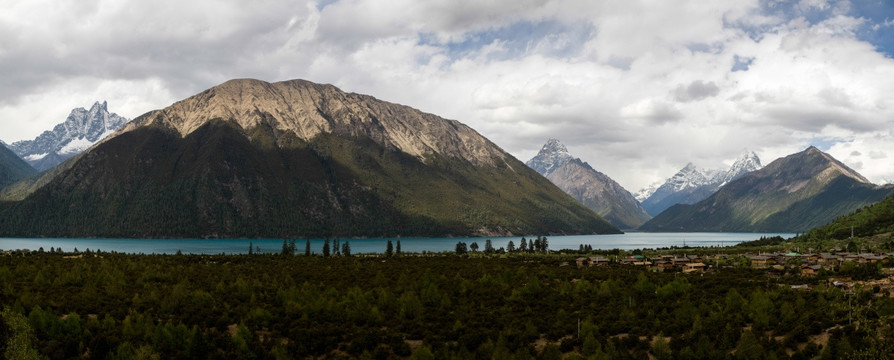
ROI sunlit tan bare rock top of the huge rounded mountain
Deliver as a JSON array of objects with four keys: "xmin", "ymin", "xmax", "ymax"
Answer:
[{"xmin": 128, "ymin": 79, "xmax": 508, "ymax": 166}]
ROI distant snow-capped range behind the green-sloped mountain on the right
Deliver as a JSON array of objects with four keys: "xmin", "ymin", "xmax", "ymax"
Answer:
[{"xmin": 636, "ymin": 152, "xmax": 761, "ymax": 216}]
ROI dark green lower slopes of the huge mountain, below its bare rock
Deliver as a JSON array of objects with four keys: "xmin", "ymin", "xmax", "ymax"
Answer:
[{"xmin": 0, "ymin": 121, "xmax": 618, "ymax": 237}]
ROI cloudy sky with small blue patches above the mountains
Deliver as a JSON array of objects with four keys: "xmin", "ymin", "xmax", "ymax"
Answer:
[{"xmin": 0, "ymin": 0, "xmax": 894, "ymax": 192}]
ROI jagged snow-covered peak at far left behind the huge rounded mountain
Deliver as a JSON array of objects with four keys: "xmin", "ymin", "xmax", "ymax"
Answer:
[{"xmin": 10, "ymin": 101, "xmax": 129, "ymax": 171}]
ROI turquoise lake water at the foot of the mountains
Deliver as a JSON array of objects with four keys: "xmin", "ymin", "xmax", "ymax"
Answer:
[{"xmin": 0, "ymin": 232, "xmax": 795, "ymax": 254}]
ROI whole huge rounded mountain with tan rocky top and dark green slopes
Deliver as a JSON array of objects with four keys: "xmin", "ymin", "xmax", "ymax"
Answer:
[{"xmin": 0, "ymin": 79, "xmax": 619, "ymax": 238}]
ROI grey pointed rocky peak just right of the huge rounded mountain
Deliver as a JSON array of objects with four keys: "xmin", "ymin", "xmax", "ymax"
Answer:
[{"xmin": 526, "ymin": 139, "xmax": 651, "ymax": 229}]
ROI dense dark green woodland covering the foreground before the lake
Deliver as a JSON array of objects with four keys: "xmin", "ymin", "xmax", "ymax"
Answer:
[{"xmin": 0, "ymin": 252, "xmax": 894, "ymax": 359}]
